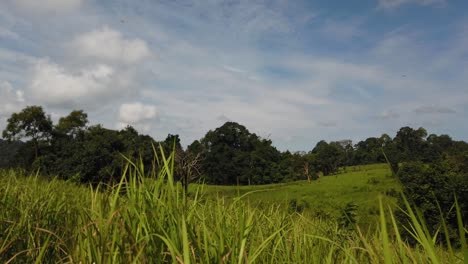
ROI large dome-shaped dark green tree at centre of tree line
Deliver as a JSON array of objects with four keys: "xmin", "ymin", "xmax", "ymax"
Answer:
[{"xmin": 195, "ymin": 122, "xmax": 281, "ymax": 185}]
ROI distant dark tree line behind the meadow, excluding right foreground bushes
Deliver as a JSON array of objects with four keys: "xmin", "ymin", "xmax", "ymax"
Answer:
[{"xmin": 0, "ymin": 106, "xmax": 468, "ymax": 185}]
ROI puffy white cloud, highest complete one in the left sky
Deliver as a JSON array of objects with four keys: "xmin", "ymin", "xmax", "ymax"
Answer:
[{"xmin": 71, "ymin": 26, "xmax": 150, "ymax": 64}]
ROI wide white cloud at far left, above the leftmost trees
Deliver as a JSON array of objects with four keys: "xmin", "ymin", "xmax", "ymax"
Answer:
[{"xmin": 27, "ymin": 60, "xmax": 114, "ymax": 106}]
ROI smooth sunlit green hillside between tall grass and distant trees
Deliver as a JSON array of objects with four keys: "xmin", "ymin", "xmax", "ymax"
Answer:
[{"xmin": 199, "ymin": 164, "xmax": 401, "ymax": 226}]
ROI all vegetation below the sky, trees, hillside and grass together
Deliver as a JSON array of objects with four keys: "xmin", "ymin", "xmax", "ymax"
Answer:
[{"xmin": 0, "ymin": 106, "xmax": 468, "ymax": 263}]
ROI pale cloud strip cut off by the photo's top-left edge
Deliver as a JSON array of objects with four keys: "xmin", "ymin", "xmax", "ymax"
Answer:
[{"xmin": 12, "ymin": 0, "xmax": 82, "ymax": 12}]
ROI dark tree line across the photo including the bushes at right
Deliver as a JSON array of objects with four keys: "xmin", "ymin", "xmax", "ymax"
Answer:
[{"xmin": 0, "ymin": 106, "xmax": 468, "ymax": 243}]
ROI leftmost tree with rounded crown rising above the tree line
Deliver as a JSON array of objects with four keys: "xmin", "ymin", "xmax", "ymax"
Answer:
[{"xmin": 2, "ymin": 106, "xmax": 52, "ymax": 159}]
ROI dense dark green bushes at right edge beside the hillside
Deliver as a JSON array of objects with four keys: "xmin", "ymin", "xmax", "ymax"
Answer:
[{"xmin": 397, "ymin": 155, "xmax": 468, "ymax": 243}]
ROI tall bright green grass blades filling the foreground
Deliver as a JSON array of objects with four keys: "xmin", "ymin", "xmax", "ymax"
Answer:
[{"xmin": 0, "ymin": 148, "xmax": 466, "ymax": 264}]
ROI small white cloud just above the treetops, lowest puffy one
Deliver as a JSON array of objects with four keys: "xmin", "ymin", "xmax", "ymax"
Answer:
[{"xmin": 119, "ymin": 102, "xmax": 157, "ymax": 125}]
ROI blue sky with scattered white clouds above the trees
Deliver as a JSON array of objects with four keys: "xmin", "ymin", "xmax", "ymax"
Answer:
[{"xmin": 0, "ymin": 0, "xmax": 468, "ymax": 151}]
